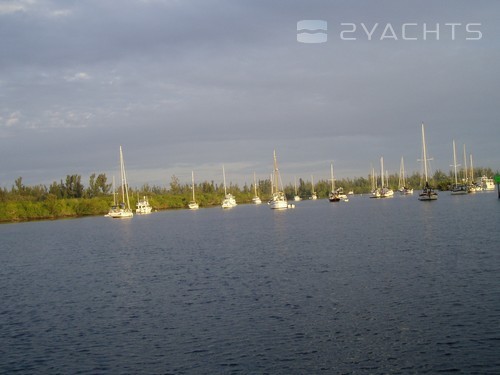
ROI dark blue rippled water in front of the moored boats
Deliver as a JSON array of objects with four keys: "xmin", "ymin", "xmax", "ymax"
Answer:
[{"xmin": 0, "ymin": 193, "xmax": 500, "ymax": 374}]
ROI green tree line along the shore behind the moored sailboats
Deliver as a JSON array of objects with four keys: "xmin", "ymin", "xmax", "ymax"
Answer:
[{"xmin": 0, "ymin": 168, "xmax": 499, "ymax": 222}]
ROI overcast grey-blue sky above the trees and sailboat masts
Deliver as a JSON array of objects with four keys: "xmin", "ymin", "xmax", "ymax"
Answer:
[{"xmin": 0, "ymin": 0, "xmax": 500, "ymax": 188}]
